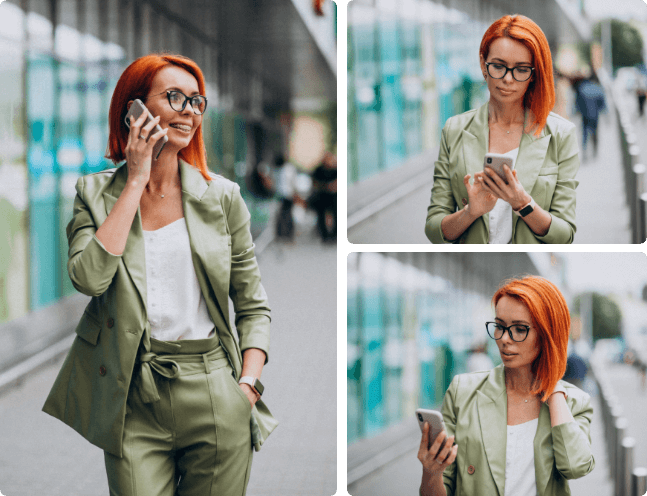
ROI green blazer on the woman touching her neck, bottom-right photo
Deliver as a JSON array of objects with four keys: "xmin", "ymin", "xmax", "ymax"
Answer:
[{"xmin": 442, "ymin": 364, "xmax": 595, "ymax": 496}]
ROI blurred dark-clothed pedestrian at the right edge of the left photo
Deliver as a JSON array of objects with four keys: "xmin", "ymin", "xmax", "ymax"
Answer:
[{"xmin": 310, "ymin": 152, "xmax": 337, "ymax": 243}]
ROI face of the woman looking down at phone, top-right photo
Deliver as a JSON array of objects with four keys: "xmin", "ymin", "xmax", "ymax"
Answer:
[{"xmin": 480, "ymin": 37, "xmax": 537, "ymax": 106}]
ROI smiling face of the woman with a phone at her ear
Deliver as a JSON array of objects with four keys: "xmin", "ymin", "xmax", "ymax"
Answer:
[{"xmin": 128, "ymin": 65, "xmax": 202, "ymax": 155}]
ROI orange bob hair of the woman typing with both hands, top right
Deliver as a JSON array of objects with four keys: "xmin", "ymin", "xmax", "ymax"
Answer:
[{"xmin": 479, "ymin": 14, "xmax": 555, "ymax": 137}]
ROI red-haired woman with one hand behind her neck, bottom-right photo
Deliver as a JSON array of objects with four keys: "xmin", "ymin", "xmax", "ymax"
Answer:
[{"xmin": 418, "ymin": 276, "xmax": 595, "ymax": 496}]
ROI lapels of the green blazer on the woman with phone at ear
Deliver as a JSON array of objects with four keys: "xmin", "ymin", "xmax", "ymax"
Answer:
[{"xmin": 103, "ymin": 159, "xmax": 231, "ymax": 349}]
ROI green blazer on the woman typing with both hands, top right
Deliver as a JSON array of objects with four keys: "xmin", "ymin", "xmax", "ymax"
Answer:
[{"xmin": 425, "ymin": 102, "xmax": 580, "ymax": 244}]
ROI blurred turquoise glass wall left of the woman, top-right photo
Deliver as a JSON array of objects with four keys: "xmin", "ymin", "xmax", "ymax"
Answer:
[{"xmin": 347, "ymin": 0, "xmax": 488, "ymax": 183}]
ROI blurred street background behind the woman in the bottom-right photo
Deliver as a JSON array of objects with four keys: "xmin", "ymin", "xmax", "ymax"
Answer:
[{"xmin": 346, "ymin": 252, "xmax": 647, "ymax": 496}]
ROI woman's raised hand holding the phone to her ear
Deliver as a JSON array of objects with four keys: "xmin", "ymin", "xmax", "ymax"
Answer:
[{"xmin": 125, "ymin": 112, "xmax": 168, "ymax": 186}]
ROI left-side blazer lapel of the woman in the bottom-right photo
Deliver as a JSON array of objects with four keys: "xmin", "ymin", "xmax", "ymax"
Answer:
[{"xmin": 477, "ymin": 364, "xmax": 508, "ymax": 496}]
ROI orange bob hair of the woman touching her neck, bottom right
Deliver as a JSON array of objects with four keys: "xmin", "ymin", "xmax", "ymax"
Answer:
[{"xmin": 492, "ymin": 276, "xmax": 571, "ymax": 401}]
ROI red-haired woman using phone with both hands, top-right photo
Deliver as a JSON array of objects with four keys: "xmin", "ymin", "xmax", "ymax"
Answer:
[{"xmin": 425, "ymin": 15, "xmax": 580, "ymax": 244}]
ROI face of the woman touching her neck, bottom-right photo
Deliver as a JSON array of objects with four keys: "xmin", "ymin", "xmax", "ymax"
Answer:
[{"xmin": 495, "ymin": 296, "xmax": 539, "ymax": 369}]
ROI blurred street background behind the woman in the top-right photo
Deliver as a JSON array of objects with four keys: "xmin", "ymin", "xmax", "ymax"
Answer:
[{"xmin": 347, "ymin": 0, "xmax": 647, "ymax": 243}]
